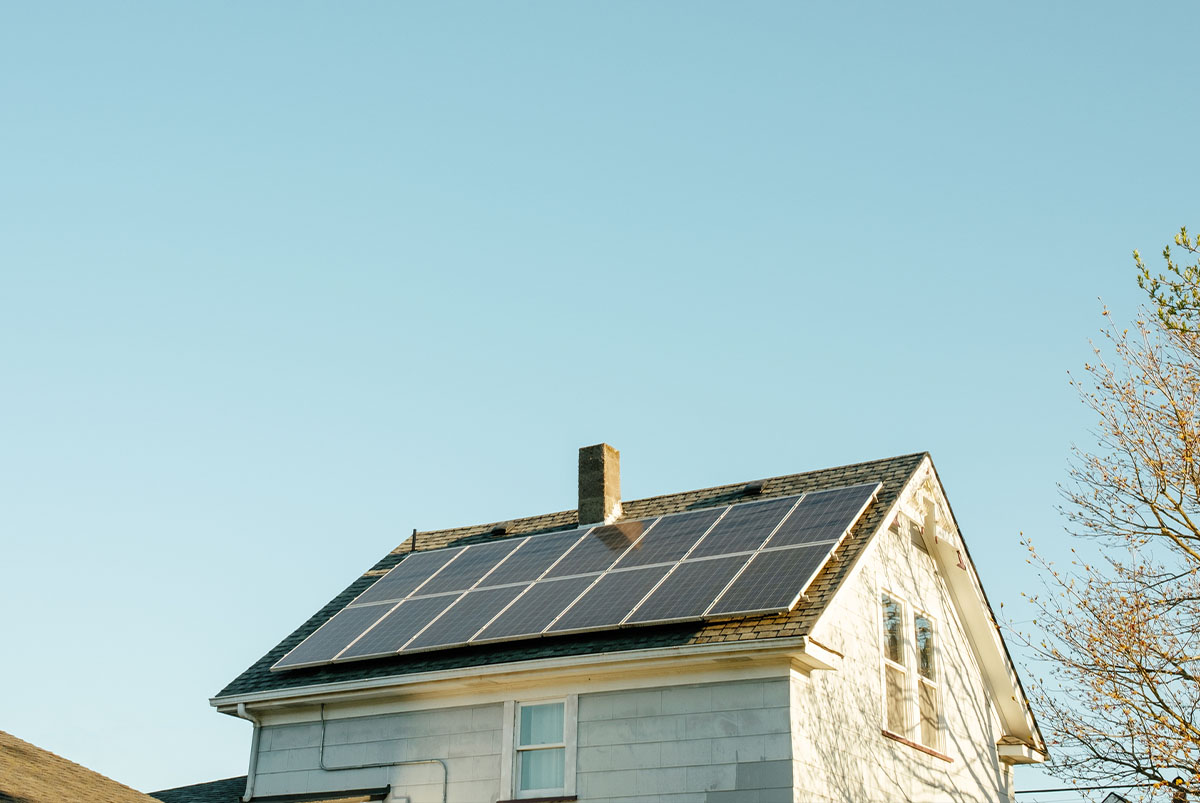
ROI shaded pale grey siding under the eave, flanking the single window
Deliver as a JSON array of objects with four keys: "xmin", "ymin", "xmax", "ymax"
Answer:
[{"xmin": 254, "ymin": 677, "xmax": 792, "ymax": 803}]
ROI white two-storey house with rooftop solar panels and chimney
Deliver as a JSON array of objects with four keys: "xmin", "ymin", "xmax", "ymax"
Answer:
[{"xmin": 182, "ymin": 444, "xmax": 1046, "ymax": 803}]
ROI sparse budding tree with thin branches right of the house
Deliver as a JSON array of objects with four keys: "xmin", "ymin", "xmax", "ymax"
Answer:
[{"xmin": 1026, "ymin": 229, "xmax": 1200, "ymax": 799}]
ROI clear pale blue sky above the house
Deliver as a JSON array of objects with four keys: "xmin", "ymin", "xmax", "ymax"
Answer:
[{"xmin": 0, "ymin": 1, "xmax": 1200, "ymax": 790}]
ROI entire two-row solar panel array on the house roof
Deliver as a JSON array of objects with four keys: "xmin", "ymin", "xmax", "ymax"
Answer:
[{"xmin": 278, "ymin": 483, "xmax": 880, "ymax": 670}]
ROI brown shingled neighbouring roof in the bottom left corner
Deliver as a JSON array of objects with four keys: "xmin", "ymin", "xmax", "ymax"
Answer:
[{"xmin": 0, "ymin": 731, "xmax": 155, "ymax": 803}]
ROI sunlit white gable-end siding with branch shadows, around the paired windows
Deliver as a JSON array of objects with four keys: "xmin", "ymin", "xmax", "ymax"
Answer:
[{"xmin": 792, "ymin": 532, "xmax": 1009, "ymax": 803}]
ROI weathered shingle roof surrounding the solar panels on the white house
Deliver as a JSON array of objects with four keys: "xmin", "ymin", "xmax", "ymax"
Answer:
[{"xmin": 217, "ymin": 453, "xmax": 926, "ymax": 701}]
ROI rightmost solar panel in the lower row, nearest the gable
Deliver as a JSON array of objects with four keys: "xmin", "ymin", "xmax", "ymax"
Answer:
[{"xmin": 708, "ymin": 544, "xmax": 833, "ymax": 616}]
